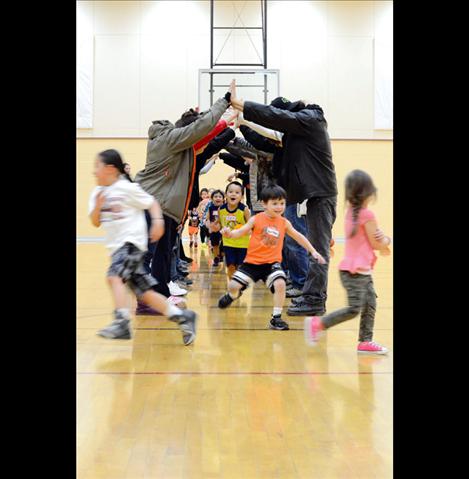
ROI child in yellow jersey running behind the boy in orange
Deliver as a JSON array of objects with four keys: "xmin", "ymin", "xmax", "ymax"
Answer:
[{"xmin": 218, "ymin": 181, "xmax": 251, "ymax": 279}]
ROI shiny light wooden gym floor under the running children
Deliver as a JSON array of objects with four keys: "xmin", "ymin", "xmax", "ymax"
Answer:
[{"xmin": 77, "ymin": 244, "xmax": 393, "ymax": 479}]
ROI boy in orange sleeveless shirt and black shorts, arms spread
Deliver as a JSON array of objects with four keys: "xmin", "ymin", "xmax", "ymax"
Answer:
[{"xmin": 218, "ymin": 185, "xmax": 325, "ymax": 330}]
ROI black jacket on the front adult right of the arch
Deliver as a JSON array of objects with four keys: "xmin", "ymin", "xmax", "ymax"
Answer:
[{"xmin": 244, "ymin": 101, "xmax": 337, "ymax": 204}]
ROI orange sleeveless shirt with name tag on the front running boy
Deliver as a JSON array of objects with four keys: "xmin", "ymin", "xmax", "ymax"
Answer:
[{"xmin": 244, "ymin": 212, "xmax": 286, "ymax": 264}]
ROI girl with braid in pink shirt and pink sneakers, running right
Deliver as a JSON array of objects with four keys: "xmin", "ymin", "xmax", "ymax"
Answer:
[{"xmin": 305, "ymin": 170, "xmax": 391, "ymax": 354}]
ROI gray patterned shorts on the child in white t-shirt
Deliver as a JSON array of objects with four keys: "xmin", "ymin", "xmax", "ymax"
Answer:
[{"xmin": 107, "ymin": 243, "xmax": 158, "ymax": 296}]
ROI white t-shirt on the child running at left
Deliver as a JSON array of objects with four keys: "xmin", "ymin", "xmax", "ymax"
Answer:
[{"xmin": 88, "ymin": 179, "xmax": 154, "ymax": 254}]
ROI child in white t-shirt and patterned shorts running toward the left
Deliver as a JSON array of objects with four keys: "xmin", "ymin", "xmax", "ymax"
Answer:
[{"xmin": 89, "ymin": 150, "xmax": 197, "ymax": 345}]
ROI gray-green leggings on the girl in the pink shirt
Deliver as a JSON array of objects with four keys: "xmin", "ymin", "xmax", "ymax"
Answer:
[{"xmin": 321, "ymin": 271, "xmax": 377, "ymax": 341}]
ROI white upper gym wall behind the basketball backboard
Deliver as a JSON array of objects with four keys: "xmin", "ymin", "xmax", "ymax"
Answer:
[{"xmin": 77, "ymin": 0, "xmax": 392, "ymax": 139}]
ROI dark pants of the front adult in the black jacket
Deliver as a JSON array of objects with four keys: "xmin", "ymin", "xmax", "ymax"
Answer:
[{"xmin": 302, "ymin": 196, "xmax": 337, "ymax": 309}]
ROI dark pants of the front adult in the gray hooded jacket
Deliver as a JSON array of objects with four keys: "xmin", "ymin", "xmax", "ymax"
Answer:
[{"xmin": 143, "ymin": 215, "xmax": 177, "ymax": 298}]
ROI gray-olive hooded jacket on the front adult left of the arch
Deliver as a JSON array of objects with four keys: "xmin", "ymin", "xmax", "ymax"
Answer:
[{"xmin": 135, "ymin": 98, "xmax": 229, "ymax": 223}]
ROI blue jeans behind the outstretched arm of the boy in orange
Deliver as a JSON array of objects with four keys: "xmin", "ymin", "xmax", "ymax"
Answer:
[{"xmin": 283, "ymin": 203, "xmax": 308, "ymax": 289}]
